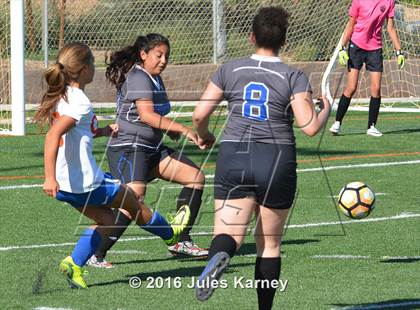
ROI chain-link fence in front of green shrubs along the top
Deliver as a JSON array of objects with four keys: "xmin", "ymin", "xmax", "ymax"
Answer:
[{"xmin": 4, "ymin": 0, "xmax": 350, "ymax": 64}]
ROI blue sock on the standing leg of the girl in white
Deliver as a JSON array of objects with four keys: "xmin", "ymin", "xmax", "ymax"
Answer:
[{"xmin": 71, "ymin": 228, "xmax": 102, "ymax": 267}]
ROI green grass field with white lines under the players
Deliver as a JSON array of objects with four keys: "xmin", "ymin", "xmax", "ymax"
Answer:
[{"xmin": 0, "ymin": 112, "xmax": 420, "ymax": 309}]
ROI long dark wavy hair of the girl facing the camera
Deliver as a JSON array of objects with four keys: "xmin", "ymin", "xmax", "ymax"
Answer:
[{"xmin": 105, "ymin": 33, "xmax": 170, "ymax": 89}]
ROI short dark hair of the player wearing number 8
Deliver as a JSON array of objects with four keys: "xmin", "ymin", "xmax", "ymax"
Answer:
[{"xmin": 252, "ymin": 6, "xmax": 289, "ymax": 53}]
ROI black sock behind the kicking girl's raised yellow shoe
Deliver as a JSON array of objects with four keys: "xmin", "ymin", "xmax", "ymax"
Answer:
[{"xmin": 176, "ymin": 187, "xmax": 203, "ymax": 241}]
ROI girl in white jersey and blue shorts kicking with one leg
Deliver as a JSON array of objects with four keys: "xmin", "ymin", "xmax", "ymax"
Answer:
[{"xmin": 35, "ymin": 43, "xmax": 189, "ymax": 288}]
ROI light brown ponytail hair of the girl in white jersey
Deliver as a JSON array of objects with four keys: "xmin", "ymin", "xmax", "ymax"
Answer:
[{"xmin": 34, "ymin": 42, "xmax": 93, "ymax": 127}]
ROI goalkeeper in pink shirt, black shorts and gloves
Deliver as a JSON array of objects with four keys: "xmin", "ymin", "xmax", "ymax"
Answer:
[{"xmin": 330, "ymin": 0, "xmax": 405, "ymax": 137}]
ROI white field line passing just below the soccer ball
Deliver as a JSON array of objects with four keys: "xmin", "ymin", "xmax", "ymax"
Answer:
[{"xmin": 0, "ymin": 213, "xmax": 420, "ymax": 252}]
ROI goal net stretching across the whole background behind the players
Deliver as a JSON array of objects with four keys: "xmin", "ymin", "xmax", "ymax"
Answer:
[{"xmin": 0, "ymin": 0, "xmax": 420, "ymax": 134}]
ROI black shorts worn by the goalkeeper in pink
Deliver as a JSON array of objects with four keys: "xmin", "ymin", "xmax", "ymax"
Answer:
[{"xmin": 348, "ymin": 42, "xmax": 384, "ymax": 72}]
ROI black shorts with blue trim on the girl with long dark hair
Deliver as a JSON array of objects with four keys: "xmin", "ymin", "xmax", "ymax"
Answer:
[{"xmin": 107, "ymin": 146, "xmax": 196, "ymax": 184}]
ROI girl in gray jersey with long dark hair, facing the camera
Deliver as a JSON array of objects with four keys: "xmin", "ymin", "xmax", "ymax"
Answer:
[{"xmin": 89, "ymin": 34, "xmax": 208, "ymax": 268}]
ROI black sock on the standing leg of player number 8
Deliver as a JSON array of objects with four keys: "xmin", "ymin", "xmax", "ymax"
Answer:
[{"xmin": 255, "ymin": 257, "xmax": 281, "ymax": 310}]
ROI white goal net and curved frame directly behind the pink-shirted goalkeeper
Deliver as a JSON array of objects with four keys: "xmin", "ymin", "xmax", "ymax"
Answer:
[{"xmin": 322, "ymin": 1, "xmax": 420, "ymax": 112}]
